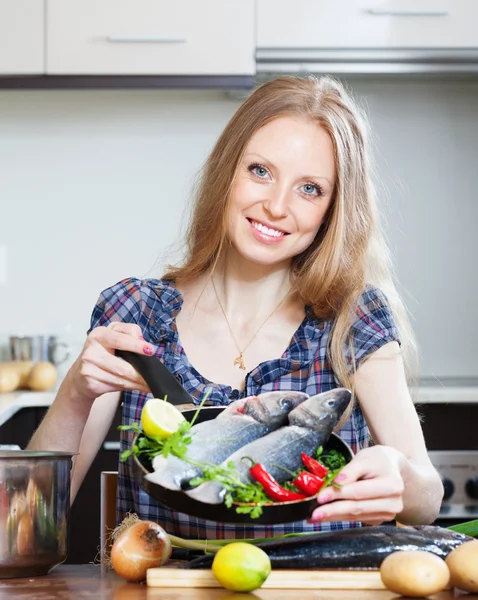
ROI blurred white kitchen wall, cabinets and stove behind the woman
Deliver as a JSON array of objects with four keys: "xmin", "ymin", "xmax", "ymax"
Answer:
[{"xmin": 0, "ymin": 0, "xmax": 478, "ymax": 562}]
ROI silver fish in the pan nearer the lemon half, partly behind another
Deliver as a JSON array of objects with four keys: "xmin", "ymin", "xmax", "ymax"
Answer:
[{"xmin": 146, "ymin": 391, "xmax": 309, "ymax": 491}]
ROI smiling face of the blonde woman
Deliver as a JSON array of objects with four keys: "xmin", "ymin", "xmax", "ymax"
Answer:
[{"xmin": 228, "ymin": 116, "xmax": 335, "ymax": 265}]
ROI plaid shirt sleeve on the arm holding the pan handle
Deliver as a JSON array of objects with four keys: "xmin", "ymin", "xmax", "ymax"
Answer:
[{"xmin": 87, "ymin": 278, "xmax": 141, "ymax": 333}]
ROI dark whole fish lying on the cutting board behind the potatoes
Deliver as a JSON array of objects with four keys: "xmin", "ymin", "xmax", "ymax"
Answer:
[{"xmin": 185, "ymin": 525, "xmax": 473, "ymax": 569}]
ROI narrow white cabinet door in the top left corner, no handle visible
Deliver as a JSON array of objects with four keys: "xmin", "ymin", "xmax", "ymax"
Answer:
[{"xmin": 0, "ymin": 0, "xmax": 45, "ymax": 75}]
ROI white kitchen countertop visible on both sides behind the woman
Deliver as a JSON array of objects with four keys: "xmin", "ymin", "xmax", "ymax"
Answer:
[{"xmin": 0, "ymin": 385, "xmax": 478, "ymax": 426}]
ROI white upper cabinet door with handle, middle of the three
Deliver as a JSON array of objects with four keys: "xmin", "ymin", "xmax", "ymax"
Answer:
[{"xmin": 47, "ymin": 0, "xmax": 255, "ymax": 75}]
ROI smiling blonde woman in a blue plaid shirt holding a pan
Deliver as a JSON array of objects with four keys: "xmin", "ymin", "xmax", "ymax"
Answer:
[{"xmin": 30, "ymin": 77, "xmax": 443, "ymax": 538}]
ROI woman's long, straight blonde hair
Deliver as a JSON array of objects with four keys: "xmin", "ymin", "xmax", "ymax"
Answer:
[{"xmin": 165, "ymin": 76, "xmax": 415, "ymax": 422}]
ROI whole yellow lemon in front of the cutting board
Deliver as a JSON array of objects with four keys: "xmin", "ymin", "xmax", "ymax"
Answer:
[{"xmin": 212, "ymin": 542, "xmax": 271, "ymax": 592}]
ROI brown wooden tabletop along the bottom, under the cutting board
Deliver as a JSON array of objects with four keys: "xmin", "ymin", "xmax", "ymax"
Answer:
[{"xmin": 0, "ymin": 565, "xmax": 470, "ymax": 600}]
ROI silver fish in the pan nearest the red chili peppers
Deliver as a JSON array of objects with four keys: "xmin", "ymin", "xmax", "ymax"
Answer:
[{"xmin": 186, "ymin": 388, "xmax": 351, "ymax": 504}]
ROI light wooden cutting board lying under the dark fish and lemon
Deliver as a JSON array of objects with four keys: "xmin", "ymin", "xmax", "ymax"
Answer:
[{"xmin": 147, "ymin": 567, "xmax": 386, "ymax": 590}]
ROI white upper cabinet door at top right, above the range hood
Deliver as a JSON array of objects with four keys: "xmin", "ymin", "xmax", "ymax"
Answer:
[{"xmin": 257, "ymin": 0, "xmax": 478, "ymax": 49}]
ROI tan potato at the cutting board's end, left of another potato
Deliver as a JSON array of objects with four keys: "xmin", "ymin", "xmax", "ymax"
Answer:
[{"xmin": 380, "ymin": 550, "xmax": 450, "ymax": 597}]
